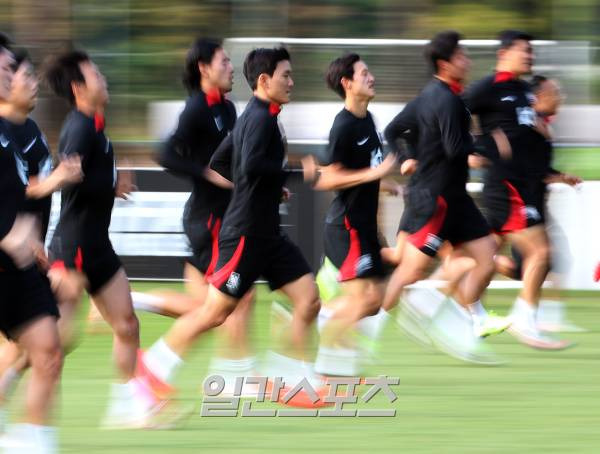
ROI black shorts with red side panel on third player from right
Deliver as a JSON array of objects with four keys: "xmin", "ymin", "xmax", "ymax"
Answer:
[{"xmin": 399, "ymin": 189, "xmax": 490, "ymax": 257}]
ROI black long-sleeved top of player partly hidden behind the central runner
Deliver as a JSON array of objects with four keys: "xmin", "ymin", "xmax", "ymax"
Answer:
[{"xmin": 158, "ymin": 92, "xmax": 236, "ymax": 218}]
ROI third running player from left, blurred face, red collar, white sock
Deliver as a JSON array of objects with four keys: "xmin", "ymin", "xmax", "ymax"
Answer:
[{"xmin": 45, "ymin": 51, "xmax": 153, "ymax": 427}]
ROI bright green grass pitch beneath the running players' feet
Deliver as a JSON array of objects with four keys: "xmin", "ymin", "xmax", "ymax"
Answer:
[{"xmin": 10, "ymin": 284, "xmax": 600, "ymax": 454}]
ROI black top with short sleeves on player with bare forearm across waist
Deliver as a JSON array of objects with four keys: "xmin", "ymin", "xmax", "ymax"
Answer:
[{"xmin": 323, "ymin": 109, "xmax": 383, "ymax": 228}]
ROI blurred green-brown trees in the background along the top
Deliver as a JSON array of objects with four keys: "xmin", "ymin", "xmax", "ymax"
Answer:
[{"xmin": 0, "ymin": 0, "xmax": 600, "ymax": 139}]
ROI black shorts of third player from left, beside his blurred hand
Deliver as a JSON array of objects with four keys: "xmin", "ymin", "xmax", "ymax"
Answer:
[{"xmin": 48, "ymin": 234, "xmax": 123, "ymax": 295}]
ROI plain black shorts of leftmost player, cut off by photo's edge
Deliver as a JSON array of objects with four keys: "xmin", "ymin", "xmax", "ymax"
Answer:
[{"xmin": 0, "ymin": 265, "xmax": 59, "ymax": 339}]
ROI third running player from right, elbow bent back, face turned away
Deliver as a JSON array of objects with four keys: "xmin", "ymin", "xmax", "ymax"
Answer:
[{"xmin": 383, "ymin": 31, "xmax": 509, "ymax": 362}]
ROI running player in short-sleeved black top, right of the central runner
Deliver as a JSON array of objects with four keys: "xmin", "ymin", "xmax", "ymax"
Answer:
[{"xmin": 315, "ymin": 53, "xmax": 396, "ymax": 376}]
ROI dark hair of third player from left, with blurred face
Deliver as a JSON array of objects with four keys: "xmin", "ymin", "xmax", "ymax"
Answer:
[{"xmin": 43, "ymin": 50, "xmax": 90, "ymax": 105}]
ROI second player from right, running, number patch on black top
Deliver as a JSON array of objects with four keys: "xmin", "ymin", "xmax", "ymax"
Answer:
[{"xmin": 465, "ymin": 30, "xmax": 564, "ymax": 350}]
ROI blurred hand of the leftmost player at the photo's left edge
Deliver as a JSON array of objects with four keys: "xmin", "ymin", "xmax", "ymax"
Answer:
[{"xmin": 0, "ymin": 214, "xmax": 39, "ymax": 269}]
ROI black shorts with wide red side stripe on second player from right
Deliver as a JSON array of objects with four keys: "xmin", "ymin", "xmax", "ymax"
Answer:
[{"xmin": 483, "ymin": 180, "xmax": 545, "ymax": 235}]
